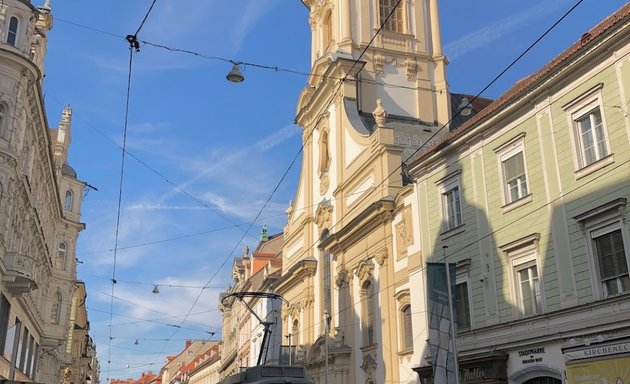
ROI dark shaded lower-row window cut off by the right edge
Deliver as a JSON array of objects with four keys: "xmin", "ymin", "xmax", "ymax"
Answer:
[{"xmin": 574, "ymin": 198, "xmax": 630, "ymax": 299}]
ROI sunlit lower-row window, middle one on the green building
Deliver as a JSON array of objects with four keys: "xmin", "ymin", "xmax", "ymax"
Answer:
[{"xmin": 501, "ymin": 233, "xmax": 544, "ymax": 318}]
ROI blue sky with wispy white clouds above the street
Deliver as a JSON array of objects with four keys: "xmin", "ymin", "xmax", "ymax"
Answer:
[{"xmin": 44, "ymin": 0, "xmax": 624, "ymax": 382}]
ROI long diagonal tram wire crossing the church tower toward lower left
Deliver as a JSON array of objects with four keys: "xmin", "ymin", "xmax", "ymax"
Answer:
[{"xmin": 142, "ymin": 0, "xmax": 410, "ymax": 368}]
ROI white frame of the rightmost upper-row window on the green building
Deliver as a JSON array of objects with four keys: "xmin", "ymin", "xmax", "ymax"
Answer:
[{"xmin": 562, "ymin": 83, "xmax": 614, "ymax": 179}]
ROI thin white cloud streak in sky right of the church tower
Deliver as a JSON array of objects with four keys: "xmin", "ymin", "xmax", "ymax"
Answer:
[{"xmin": 444, "ymin": 1, "xmax": 563, "ymax": 61}]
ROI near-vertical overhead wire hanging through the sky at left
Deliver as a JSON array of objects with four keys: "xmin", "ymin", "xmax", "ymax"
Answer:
[{"xmin": 107, "ymin": 0, "xmax": 157, "ymax": 380}]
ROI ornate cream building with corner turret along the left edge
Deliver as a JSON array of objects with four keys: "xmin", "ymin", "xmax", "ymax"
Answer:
[{"xmin": 0, "ymin": 0, "xmax": 91, "ymax": 383}]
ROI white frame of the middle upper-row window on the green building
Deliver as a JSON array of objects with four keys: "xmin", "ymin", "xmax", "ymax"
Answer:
[{"xmin": 494, "ymin": 132, "xmax": 532, "ymax": 213}]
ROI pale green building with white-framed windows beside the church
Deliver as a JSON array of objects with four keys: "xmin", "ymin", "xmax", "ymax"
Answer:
[{"xmin": 407, "ymin": 3, "xmax": 630, "ymax": 384}]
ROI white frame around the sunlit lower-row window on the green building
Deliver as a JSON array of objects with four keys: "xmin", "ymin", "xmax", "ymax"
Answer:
[{"xmin": 500, "ymin": 233, "xmax": 546, "ymax": 319}]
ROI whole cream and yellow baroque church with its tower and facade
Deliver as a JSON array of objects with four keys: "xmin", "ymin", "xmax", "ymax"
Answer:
[{"xmin": 276, "ymin": 0, "xmax": 450, "ymax": 384}]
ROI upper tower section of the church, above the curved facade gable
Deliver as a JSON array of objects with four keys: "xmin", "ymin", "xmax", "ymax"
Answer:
[{"xmin": 303, "ymin": 0, "xmax": 449, "ymax": 126}]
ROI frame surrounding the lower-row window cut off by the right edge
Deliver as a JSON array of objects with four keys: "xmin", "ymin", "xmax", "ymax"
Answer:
[{"xmin": 574, "ymin": 198, "xmax": 630, "ymax": 300}]
